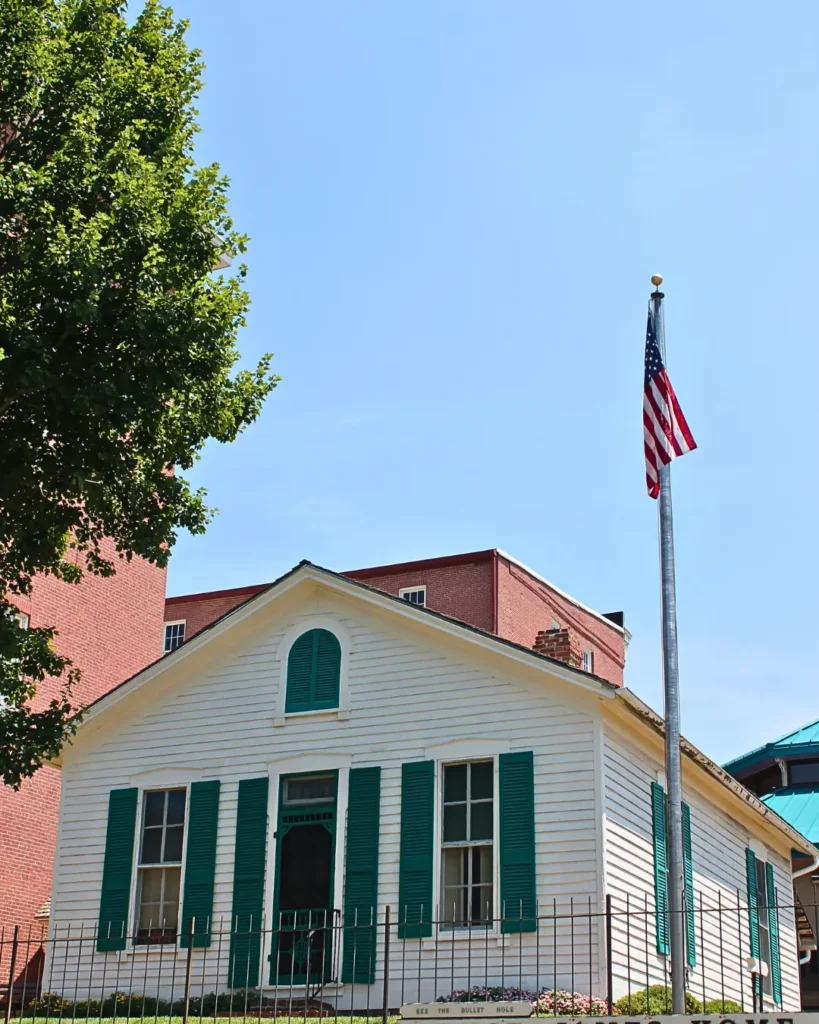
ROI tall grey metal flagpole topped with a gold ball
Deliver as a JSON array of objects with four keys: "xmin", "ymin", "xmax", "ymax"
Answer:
[{"xmin": 651, "ymin": 274, "xmax": 686, "ymax": 1014}]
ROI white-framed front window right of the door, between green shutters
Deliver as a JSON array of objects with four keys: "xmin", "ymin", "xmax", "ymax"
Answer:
[{"xmin": 441, "ymin": 761, "xmax": 494, "ymax": 928}]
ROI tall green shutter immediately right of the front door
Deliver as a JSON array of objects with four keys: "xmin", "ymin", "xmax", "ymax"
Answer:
[{"xmin": 341, "ymin": 768, "xmax": 381, "ymax": 985}]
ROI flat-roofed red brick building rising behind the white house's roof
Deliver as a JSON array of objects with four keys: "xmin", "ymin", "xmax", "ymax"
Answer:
[{"xmin": 165, "ymin": 548, "xmax": 629, "ymax": 686}]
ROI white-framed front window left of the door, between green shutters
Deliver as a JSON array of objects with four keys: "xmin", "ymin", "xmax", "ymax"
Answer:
[{"xmin": 135, "ymin": 790, "xmax": 185, "ymax": 944}]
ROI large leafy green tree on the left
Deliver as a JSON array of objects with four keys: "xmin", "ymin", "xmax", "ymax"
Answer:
[{"xmin": 0, "ymin": 0, "xmax": 277, "ymax": 787}]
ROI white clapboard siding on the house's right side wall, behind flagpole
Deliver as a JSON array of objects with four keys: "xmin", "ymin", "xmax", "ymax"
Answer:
[{"xmin": 604, "ymin": 723, "xmax": 800, "ymax": 1010}]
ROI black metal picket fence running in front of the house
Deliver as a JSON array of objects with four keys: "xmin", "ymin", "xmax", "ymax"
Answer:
[{"xmin": 0, "ymin": 895, "xmax": 815, "ymax": 1024}]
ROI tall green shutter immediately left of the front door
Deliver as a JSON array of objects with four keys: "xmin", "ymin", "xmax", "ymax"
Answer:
[{"xmin": 228, "ymin": 778, "xmax": 267, "ymax": 988}]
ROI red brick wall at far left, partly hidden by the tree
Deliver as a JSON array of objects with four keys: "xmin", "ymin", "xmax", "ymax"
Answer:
[{"xmin": 0, "ymin": 546, "xmax": 166, "ymax": 935}]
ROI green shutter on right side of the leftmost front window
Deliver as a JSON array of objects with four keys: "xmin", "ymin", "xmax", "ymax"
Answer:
[{"xmin": 180, "ymin": 779, "xmax": 219, "ymax": 948}]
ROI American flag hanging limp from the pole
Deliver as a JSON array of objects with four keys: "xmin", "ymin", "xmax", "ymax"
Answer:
[{"xmin": 643, "ymin": 305, "xmax": 697, "ymax": 498}]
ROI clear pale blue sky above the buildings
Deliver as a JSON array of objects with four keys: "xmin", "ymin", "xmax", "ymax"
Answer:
[{"xmin": 164, "ymin": 0, "xmax": 819, "ymax": 760}]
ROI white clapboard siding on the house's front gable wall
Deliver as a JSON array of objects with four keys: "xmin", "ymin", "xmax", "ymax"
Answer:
[{"xmin": 49, "ymin": 598, "xmax": 602, "ymax": 1003}]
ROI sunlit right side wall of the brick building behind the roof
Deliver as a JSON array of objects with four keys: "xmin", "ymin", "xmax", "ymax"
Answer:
[{"xmin": 498, "ymin": 558, "xmax": 626, "ymax": 686}]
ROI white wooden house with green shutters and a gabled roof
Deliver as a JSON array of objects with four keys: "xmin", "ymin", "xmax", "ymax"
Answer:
[{"xmin": 43, "ymin": 563, "xmax": 819, "ymax": 1010}]
